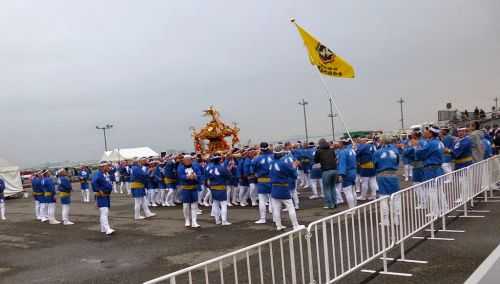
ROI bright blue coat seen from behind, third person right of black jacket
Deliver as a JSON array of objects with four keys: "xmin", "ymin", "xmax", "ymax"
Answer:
[{"xmin": 374, "ymin": 144, "xmax": 400, "ymax": 195}]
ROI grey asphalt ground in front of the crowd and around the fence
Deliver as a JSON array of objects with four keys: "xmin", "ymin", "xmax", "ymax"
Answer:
[{"xmin": 0, "ymin": 183, "xmax": 500, "ymax": 283}]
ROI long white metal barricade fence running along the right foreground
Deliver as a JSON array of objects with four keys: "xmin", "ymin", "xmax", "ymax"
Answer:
[{"xmin": 146, "ymin": 156, "xmax": 500, "ymax": 284}]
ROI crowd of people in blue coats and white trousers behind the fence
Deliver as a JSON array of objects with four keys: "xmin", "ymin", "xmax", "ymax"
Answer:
[{"xmin": 0, "ymin": 123, "xmax": 494, "ymax": 235}]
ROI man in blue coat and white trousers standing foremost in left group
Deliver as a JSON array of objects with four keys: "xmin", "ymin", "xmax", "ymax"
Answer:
[{"xmin": 92, "ymin": 162, "xmax": 115, "ymax": 236}]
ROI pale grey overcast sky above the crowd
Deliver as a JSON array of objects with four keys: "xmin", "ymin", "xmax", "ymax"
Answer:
[{"xmin": 0, "ymin": 0, "xmax": 500, "ymax": 166}]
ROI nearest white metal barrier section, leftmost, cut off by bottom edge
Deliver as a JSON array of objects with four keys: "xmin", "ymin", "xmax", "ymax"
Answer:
[{"xmin": 145, "ymin": 228, "xmax": 307, "ymax": 284}]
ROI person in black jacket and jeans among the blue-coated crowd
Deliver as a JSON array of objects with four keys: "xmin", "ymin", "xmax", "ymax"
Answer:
[{"xmin": 314, "ymin": 139, "xmax": 337, "ymax": 209}]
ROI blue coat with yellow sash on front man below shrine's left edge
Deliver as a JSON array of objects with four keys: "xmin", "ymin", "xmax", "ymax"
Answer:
[{"xmin": 177, "ymin": 163, "xmax": 202, "ymax": 203}]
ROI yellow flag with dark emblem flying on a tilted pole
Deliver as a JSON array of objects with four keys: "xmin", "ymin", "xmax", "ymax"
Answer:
[{"xmin": 292, "ymin": 19, "xmax": 354, "ymax": 78}]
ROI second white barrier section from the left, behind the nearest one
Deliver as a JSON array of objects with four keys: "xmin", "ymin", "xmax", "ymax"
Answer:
[{"xmin": 307, "ymin": 196, "xmax": 393, "ymax": 283}]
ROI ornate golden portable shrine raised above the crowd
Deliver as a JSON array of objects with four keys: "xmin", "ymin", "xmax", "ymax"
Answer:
[{"xmin": 191, "ymin": 106, "xmax": 240, "ymax": 154}]
